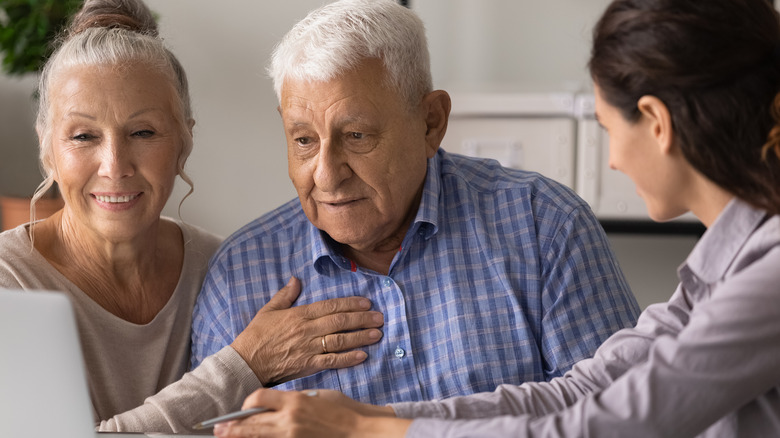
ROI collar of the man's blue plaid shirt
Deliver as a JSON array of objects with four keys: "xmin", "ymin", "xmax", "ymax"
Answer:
[{"xmin": 309, "ymin": 150, "xmax": 444, "ymax": 274}]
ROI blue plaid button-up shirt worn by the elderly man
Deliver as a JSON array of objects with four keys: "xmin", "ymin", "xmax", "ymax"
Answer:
[{"xmin": 192, "ymin": 150, "xmax": 639, "ymax": 404}]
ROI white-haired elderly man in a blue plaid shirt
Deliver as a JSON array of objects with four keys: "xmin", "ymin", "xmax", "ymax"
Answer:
[{"xmin": 193, "ymin": 0, "xmax": 639, "ymax": 404}]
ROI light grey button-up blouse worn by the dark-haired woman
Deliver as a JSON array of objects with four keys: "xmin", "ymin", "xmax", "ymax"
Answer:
[{"xmin": 391, "ymin": 199, "xmax": 780, "ymax": 438}]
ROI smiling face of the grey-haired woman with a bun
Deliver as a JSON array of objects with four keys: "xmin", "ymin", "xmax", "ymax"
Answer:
[{"xmin": 50, "ymin": 65, "xmax": 182, "ymax": 241}]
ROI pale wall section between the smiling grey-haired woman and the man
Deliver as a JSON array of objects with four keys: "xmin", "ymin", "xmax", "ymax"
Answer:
[{"xmin": 148, "ymin": 0, "xmax": 322, "ymax": 235}]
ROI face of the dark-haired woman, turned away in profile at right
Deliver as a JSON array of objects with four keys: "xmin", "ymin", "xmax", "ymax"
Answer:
[{"xmin": 594, "ymin": 85, "xmax": 689, "ymax": 221}]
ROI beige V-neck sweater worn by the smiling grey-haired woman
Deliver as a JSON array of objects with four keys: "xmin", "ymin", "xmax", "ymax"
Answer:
[{"xmin": 0, "ymin": 219, "xmax": 260, "ymax": 432}]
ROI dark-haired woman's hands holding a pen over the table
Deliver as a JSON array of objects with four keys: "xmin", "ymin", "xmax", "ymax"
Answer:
[{"xmin": 214, "ymin": 389, "xmax": 411, "ymax": 438}]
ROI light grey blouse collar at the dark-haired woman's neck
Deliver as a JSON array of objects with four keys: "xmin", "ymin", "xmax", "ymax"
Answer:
[{"xmin": 679, "ymin": 198, "xmax": 767, "ymax": 283}]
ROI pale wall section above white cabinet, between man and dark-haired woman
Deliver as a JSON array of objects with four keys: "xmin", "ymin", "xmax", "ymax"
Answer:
[{"xmin": 412, "ymin": 0, "xmax": 609, "ymax": 92}]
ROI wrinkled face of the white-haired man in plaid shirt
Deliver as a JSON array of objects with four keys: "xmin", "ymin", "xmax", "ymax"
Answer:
[{"xmin": 280, "ymin": 59, "xmax": 438, "ymax": 255}]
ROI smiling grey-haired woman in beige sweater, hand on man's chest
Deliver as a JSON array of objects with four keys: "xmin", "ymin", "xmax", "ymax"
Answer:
[{"xmin": 0, "ymin": 0, "xmax": 382, "ymax": 432}]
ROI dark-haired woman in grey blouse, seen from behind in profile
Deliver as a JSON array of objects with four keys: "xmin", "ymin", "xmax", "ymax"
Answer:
[{"xmin": 216, "ymin": 0, "xmax": 780, "ymax": 438}]
